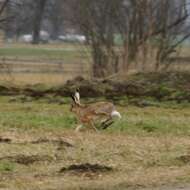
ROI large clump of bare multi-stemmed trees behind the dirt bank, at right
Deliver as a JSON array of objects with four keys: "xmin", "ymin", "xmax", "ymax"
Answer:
[{"xmin": 68, "ymin": 0, "xmax": 189, "ymax": 77}]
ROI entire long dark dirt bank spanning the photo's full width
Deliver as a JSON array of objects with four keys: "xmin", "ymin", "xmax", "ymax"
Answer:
[{"xmin": 0, "ymin": 72, "xmax": 190, "ymax": 101}]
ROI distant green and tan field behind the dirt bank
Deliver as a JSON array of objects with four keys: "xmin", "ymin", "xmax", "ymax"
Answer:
[{"xmin": 0, "ymin": 43, "xmax": 190, "ymax": 85}]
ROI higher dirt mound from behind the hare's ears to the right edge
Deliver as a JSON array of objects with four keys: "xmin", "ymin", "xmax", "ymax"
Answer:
[{"xmin": 60, "ymin": 72, "xmax": 190, "ymax": 102}]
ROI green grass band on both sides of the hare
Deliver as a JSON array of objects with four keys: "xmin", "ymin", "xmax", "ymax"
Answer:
[{"xmin": 0, "ymin": 97, "xmax": 190, "ymax": 135}]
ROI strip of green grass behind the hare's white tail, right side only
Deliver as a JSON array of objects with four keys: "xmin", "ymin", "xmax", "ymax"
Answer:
[{"xmin": 109, "ymin": 107, "xmax": 190, "ymax": 135}]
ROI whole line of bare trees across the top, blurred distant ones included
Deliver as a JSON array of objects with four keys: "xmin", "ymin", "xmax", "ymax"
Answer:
[{"xmin": 0, "ymin": 0, "xmax": 190, "ymax": 77}]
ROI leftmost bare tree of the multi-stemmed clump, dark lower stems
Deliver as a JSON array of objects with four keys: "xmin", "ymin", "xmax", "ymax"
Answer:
[{"xmin": 66, "ymin": 0, "xmax": 118, "ymax": 77}]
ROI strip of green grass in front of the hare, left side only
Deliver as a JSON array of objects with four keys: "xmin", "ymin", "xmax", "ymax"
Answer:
[{"xmin": 0, "ymin": 99, "xmax": 75, "ymax": 130}]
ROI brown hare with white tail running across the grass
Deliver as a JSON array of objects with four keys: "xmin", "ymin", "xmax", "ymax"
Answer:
[{"xmin": 71, "ymin": 91, "xmax": 121, "ymax": 131}]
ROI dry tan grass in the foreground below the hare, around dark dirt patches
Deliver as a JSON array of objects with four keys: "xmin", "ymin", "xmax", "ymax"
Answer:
[{"xmin": 0, "ymin": 130, "xmax": 190, "ymax": 190}]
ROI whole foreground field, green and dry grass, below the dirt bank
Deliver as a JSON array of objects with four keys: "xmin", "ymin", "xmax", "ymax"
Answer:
[{"xmin": 0, "ymin": 97, "xmax": 190, "ymax": 190}]
